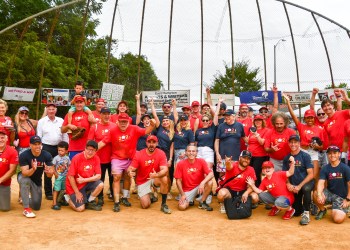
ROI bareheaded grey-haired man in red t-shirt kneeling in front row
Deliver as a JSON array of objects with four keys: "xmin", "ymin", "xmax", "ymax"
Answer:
[{"xmin": 174, "ymin": 146, "xmax": 214, "ymax": 211}]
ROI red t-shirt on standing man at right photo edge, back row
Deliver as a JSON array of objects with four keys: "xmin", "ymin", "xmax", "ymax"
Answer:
[{"xmin": 324, "ymin": 110, "xmax": 350, "ymax": 148}]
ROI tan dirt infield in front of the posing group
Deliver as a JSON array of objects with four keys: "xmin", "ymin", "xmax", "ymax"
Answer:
[{"xmin": 0, "ymin": 177, "xmax": 350, "ymax": 249}]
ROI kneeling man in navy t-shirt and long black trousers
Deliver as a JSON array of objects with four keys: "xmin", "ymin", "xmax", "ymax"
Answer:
[{"xmin": 282, "ymin": 135, "xmax": 314, "ymax": 225}]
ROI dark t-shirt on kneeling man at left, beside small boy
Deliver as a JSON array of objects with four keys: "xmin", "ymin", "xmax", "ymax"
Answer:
[{"xmin": 19, "ymin": 149, "xmax": 53, "ymax": 186}]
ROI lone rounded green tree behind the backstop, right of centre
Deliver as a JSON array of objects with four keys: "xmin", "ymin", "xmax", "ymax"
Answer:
[{"xmin": 211, "ymin": 60, "xmax": 262, "ymax": 96}]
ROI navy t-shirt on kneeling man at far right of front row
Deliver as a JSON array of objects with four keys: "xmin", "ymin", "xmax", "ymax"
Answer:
[{"xmin": 320, "ymin": 162, "xmax": 350, "ymax": 199}]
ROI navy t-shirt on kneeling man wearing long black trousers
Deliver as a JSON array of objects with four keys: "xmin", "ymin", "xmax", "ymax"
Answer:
[{"xmin": 282, "ymin": 151, "xmax": 314, "ymax": 186}]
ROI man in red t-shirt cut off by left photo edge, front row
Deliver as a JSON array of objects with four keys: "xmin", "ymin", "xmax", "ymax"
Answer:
[{"xmin": 0, "ymin": 128, "xmax": 18, "ymax": 211}]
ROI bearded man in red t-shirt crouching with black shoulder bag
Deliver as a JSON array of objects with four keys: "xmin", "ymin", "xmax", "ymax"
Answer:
[{"xmin": 218, "ymin": 150, "xmax": 259, "ymax": 213}]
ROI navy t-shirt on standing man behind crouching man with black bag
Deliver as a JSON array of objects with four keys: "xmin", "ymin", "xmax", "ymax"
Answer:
[{"xmin": 215, "ymin": 122, "xmax": 245, "ymax": 161}]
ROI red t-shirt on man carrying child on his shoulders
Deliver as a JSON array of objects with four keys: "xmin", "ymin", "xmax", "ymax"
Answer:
[{"xmin": 62, "ymin": 111, "xmax": 90, "ymax": 151}]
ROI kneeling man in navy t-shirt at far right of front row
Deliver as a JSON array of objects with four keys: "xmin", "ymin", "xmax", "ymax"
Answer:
[{"xmin": 314, "ymin": 146, "xmax": 350, "ymax": 224}]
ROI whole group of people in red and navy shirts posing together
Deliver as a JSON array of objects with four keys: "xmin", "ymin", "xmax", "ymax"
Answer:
[{"xmin": 0, "ymin": 82, "xmax": 350, "ymax": 225}]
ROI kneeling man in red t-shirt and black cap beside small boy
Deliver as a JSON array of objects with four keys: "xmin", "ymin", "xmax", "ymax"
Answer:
[{"xmin": 65, "ymin": 140, "xmax": 103, "ymax": 212}]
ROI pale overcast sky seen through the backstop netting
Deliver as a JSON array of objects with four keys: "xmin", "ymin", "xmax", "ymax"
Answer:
[{"xmin": 97, "ymin": 0, "xmax": 350, "ymax": 101}]
